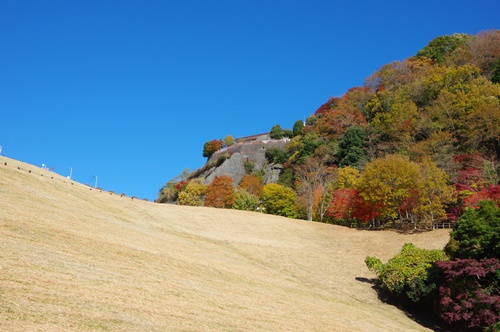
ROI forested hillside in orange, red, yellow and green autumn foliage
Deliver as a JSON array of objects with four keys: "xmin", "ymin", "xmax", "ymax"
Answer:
[{"xmin": 159, "ymin": 30, "xmax": 500, "ymax": 226}]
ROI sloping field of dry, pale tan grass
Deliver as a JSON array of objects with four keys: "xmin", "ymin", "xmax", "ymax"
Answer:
[{"xmin": 0, "ymin": 157, "xmax": 449, "ymax": 331}]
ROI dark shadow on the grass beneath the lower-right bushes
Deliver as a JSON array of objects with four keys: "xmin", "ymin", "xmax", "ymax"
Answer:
[{"xmin": 354, "ymin": 277, "xmax": 456, "ymax": 332}]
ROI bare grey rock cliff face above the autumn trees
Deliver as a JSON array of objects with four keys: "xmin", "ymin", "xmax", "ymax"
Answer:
[{"xmin": 196, "ymin": 135, "xmax": 287, "ymax": 186}]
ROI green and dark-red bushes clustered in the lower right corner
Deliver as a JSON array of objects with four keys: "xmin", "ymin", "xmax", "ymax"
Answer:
[{"xmin": 365, "ymin": 201, "xmax": 500, "ymax": 331}]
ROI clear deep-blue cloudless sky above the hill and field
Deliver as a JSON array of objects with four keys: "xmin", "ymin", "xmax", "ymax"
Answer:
[{"xmin": 0, "ymin": 0, "xmax": 500, "ymax": 199}]
